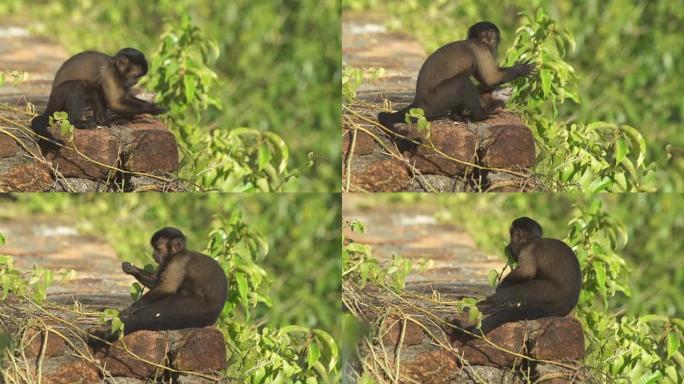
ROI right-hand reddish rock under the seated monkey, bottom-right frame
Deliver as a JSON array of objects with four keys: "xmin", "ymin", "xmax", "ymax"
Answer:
[{"xmin": 529, "ymin": 317, "xmax": 584, "ymax": 361}]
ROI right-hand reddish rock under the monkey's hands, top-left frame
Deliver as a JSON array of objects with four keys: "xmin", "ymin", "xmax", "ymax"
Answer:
[{"xmin": 124, "ymin": 127, "xmax": 178, "ymax": 173}]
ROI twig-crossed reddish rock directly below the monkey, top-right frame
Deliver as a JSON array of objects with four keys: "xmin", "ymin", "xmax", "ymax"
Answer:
[{"xmin": 411, "ymin": 120, "xmax": 477, "ymax": 176}]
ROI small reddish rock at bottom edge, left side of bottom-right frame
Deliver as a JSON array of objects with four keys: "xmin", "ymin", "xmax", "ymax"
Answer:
[{"xmin": 399, "ymin": 348, "xmax": 459, "ymax": 384}]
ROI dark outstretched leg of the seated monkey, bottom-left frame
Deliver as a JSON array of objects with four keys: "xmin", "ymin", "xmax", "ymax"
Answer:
[{"xmin": 119, "ymin": 295, "xmax": 216, "ymax": 334}]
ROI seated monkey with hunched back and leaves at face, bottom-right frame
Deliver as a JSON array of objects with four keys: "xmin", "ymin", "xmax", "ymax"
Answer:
[{"xmin": 471, "ymin": 217, "xmax": 582, "ymax": 334}]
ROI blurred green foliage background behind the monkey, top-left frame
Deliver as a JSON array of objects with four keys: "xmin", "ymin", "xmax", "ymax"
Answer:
[{"xmin": 0, "ymin": 0, "xmax": 341, "ymax": 191}]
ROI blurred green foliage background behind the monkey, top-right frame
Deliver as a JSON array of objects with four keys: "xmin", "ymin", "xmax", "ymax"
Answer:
[{"xmin": 342, "ymin": 0, "xmax": 684, "ymax": 191}]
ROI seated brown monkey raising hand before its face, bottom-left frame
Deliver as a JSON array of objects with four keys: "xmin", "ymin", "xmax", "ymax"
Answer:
[{"xmin": 119, "ymin": 227, "xmax": 228, "ymax": 334}]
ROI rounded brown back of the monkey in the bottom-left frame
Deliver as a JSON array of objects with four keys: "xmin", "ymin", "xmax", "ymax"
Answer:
[{"xmin": 179, "ymin": 252, "xmax": 228, "ymax": 312}]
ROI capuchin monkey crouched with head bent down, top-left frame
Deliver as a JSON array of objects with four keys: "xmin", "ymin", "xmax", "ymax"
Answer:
[{"xmin": 31, "ymin": 48, "xmax": 166, "ymax": 139}]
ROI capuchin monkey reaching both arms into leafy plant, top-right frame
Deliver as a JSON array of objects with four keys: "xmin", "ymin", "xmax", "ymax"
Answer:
[{"xmin": 378, "ymin": 21, "xmax": 535, "ymax": 130}]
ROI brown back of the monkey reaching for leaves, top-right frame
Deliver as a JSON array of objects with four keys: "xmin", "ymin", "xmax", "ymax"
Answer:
[{"xmin": 415, "ymin": 40, "xmax": 477, "ymax": 101}]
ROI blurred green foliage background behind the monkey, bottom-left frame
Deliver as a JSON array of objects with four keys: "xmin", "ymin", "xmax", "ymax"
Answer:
[{"xmin": 0, "ymin": 193, "xmax": 341, "ymax": 335}]
